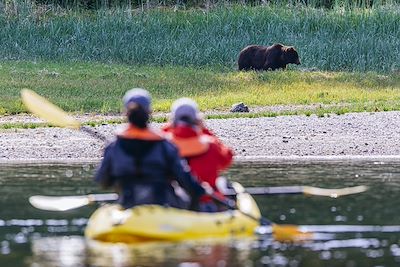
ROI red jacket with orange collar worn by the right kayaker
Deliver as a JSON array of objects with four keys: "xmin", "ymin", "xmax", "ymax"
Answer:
[{"xmin": 163, "ymin": 125, "xmax": 233, "ymax": 201}]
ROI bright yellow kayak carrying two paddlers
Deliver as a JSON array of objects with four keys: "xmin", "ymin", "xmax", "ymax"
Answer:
[{"xmin": 85, "ymin": 183, "xmax": 261, "ymax": 243}]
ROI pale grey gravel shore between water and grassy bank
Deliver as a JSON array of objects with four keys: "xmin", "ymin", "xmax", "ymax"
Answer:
[{"xmin": 0, "ymin": 111, "xmax": 400, "ymax": 162}]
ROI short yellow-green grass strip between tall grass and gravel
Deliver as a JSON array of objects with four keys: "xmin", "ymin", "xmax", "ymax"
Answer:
[{"xmin": 0, "ymin": 62, "xmax": 400, "ymax": 116}]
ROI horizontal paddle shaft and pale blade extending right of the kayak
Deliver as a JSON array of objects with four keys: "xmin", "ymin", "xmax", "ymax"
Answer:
[{"xmin": 224, "ymin": 185, "xmax": 368, "ymax": 198}]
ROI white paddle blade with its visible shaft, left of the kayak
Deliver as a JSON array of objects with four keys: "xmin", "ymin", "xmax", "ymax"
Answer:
[{"xmin": 29, "ymin": 193, "xmax": 118, "ymax": 211}]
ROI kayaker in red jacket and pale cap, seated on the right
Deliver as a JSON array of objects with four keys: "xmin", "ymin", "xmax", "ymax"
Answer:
[{"xmin": 163, "ymin": 98, "xmax": 233, "ymax": 212}]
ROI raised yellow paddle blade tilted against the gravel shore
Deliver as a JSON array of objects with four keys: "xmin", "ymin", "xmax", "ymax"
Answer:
[{"xmin": 21, "ymin": 89, "xmax": 80, "ymax": 129}]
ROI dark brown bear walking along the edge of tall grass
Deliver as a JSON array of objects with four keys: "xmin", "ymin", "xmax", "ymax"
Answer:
[{"xmin": 238, "ymin": 44, "xmax": 300, "ymax": 70}]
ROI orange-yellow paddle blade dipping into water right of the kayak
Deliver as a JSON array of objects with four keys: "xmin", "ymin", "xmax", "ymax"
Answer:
[{"xmin": 272, "ymin": 224, "xmax": 313, "ymax": 242}]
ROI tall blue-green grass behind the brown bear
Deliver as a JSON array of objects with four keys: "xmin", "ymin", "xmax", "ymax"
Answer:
[{"xmin": 0, "ymin": 2, "xmax": 400, "ymax": 72}]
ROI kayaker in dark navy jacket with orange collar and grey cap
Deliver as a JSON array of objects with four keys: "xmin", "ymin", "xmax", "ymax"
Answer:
[{"xmin": 95, "ymin": 88, "xmax": 205, "ymax": 210}]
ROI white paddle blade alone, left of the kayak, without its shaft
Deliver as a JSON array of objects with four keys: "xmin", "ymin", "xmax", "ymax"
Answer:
[{"xmin": 29, "ymin": 196, "xmax": 91, "ymax": 211}]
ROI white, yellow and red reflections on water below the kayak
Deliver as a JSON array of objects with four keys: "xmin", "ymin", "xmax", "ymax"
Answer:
[{"xmin": 31, "ymin": 236, "xmax": 254, "ymax": 267}]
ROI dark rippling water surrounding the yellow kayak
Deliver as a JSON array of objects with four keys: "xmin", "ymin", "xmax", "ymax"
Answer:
[{"xmin": 0, "ymin": 161, "xmax": 400, "ymax": 267}]
